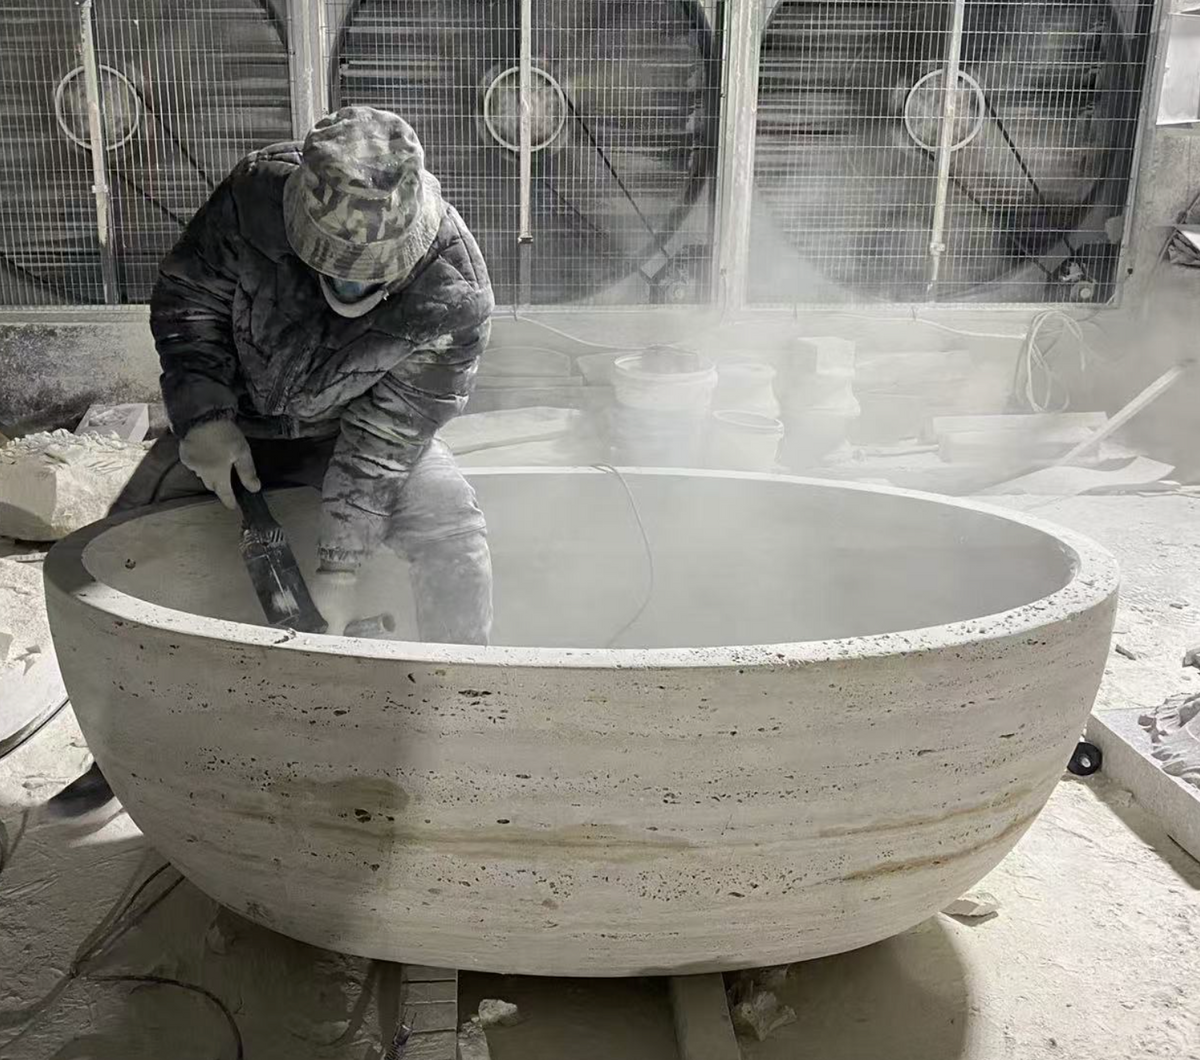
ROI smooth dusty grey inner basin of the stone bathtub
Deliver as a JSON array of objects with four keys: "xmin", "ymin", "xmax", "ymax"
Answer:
[{"xmin": 85, "ymin": 471, "xmax": 1074, "ymax": 648}]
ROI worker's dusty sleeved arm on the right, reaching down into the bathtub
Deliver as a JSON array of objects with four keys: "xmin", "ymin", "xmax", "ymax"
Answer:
[{"xmin": 319, "ymin": 319, "xmax": 491, "ymax": 570}]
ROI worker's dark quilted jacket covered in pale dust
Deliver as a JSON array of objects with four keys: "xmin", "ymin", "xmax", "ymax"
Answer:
[{"xmin": 150, "ymin": 143, "xmax": 494, "ymax": 569}]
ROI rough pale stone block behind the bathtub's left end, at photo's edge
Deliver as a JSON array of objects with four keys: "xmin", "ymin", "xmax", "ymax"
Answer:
[{"xmin": 0, "ymin": 431, "xmax": 148, "ymax": 541}]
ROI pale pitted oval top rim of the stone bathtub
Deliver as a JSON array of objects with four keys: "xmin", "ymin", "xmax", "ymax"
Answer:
[{"xmin": 43, "ymin": 466, "xmax": 1120, "ymax": 671}]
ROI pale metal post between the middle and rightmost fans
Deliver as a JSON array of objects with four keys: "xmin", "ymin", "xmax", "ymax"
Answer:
[{"xmin": 713, "ymin": 0, "xmax": 767, "ymax": 312}]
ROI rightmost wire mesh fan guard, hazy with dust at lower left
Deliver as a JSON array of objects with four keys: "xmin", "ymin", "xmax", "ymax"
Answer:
[{"xmin": 749, "ymin": 0, "xmax": 1152, "ymax": 303}]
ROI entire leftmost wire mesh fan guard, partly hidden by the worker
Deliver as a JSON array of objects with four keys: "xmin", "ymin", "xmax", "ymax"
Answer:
[{"xmin": 0, "ymin": 0, "xmax": 292, "ymax": 305}]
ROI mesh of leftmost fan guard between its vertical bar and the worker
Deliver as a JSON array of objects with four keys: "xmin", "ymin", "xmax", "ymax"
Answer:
[{"xmin": 96, "ymin": 0, "xmax": 292, "ymax": 301}]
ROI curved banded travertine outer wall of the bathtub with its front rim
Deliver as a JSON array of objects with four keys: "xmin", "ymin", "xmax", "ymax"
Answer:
[{"xmin": 47, "ymin": 480, "xmax": 1116, "ymax": 976}]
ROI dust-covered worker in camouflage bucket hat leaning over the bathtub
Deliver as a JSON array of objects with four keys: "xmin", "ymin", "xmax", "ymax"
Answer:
[{"xmin": 55, "ymin": 107, "xmax": 494, "ymax": 813}]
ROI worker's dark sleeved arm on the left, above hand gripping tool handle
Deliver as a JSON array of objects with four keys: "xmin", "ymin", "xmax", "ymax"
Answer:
[{"xmin": 150, "ymin": 167, "xmax": 240, "ymax": 437}]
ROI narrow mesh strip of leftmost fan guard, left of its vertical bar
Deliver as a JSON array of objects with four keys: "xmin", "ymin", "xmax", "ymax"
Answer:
[{"xmin": 0, "ymin": 0, "xmax": 104, "ymax": 305}]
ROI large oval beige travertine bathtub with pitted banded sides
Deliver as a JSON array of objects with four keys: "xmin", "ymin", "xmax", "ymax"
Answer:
[{"xmin": 46, "ymin": 469, "xmax": 1117, "ymax": 976}]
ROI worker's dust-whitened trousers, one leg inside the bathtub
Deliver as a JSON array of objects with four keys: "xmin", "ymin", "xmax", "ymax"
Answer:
[{"xmin": 113, "ymin": 435, "xmax": 492, "ymax": 645}]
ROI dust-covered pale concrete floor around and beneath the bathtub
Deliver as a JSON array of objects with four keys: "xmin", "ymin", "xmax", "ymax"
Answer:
[{"xmin": 0, "ymin": 498, "xmax": 1200, "ymax": 1060}]
